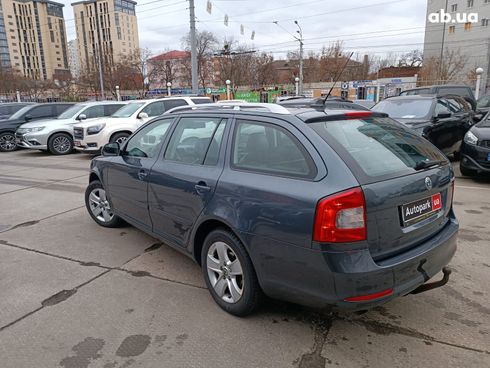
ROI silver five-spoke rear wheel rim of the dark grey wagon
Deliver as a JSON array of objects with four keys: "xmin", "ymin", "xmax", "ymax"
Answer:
[{"xmin": 206, "ymin": 241, "xmax": 243, "ymax": 303}]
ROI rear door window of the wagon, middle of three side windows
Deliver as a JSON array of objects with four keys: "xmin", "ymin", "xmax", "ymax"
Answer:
[{"xmin": 165, "ymin": 117, "xmax": 226, "ymax": 165}]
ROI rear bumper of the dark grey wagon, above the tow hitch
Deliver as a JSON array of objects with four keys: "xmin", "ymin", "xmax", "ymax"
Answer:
[{"xmin": 252, "ymin": 216, "xmax": 459, "ymax": 311}]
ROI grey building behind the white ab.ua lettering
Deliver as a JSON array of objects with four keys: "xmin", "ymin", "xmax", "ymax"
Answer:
[{"xmin": 424, "ymin": 0, "xmax": 490, "ymax": 93}]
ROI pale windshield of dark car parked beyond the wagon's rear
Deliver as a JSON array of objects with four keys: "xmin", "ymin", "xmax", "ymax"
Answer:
[{"xmin": 371, "ymin": 99, "xmax": 433, "ymax": 119}]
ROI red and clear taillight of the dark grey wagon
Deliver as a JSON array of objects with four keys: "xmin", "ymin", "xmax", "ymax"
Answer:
[{"xmin": 313, "ymin": 188, "xmax": 366, "ymax": 243}]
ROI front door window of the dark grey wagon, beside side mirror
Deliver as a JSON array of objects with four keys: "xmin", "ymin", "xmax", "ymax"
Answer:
[{"xmin": 123, "ymin": 118, "xmax": 173, "ymax": 158}]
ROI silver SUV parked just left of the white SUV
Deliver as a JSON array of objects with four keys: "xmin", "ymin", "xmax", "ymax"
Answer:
[{"xmin": 15, "ymin": 101, "xmax": 126, "ymax": 155}]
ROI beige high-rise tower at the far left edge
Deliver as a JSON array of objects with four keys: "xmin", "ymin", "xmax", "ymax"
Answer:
[{"xmin": 0, "ymin": 0, "xmax": 69, "ymax": 80}]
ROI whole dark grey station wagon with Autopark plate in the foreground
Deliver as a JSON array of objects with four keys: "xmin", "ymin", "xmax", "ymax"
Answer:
[{"xmin": 85, "ymin": 104, "xmax": 458, "ymax": 315}]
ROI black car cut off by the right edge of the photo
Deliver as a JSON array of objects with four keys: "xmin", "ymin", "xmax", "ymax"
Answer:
[{"xmin": 459, "ymin": 112, "xmax": 490, "ymax": 176}]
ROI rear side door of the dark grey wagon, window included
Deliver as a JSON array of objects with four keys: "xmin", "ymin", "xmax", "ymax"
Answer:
[{"xmin": 148, "ymin": 115, "xmax": 228, "ymax": 246}]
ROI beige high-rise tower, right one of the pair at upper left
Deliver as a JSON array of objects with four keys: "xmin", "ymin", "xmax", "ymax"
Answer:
[{"xmin": 72, "ymin": 0, "xmax": 139, "ymax": 71}]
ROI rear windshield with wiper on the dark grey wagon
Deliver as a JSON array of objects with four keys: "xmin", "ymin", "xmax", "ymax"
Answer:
[{"xmin": 310, "ymin": 118, "xmax": 446, "ymax": 184}]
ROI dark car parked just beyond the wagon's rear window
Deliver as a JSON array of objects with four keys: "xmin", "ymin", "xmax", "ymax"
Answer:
[{"xmin": 372, "ymin": 96, "xmax": 474, "ymax": 157}]
